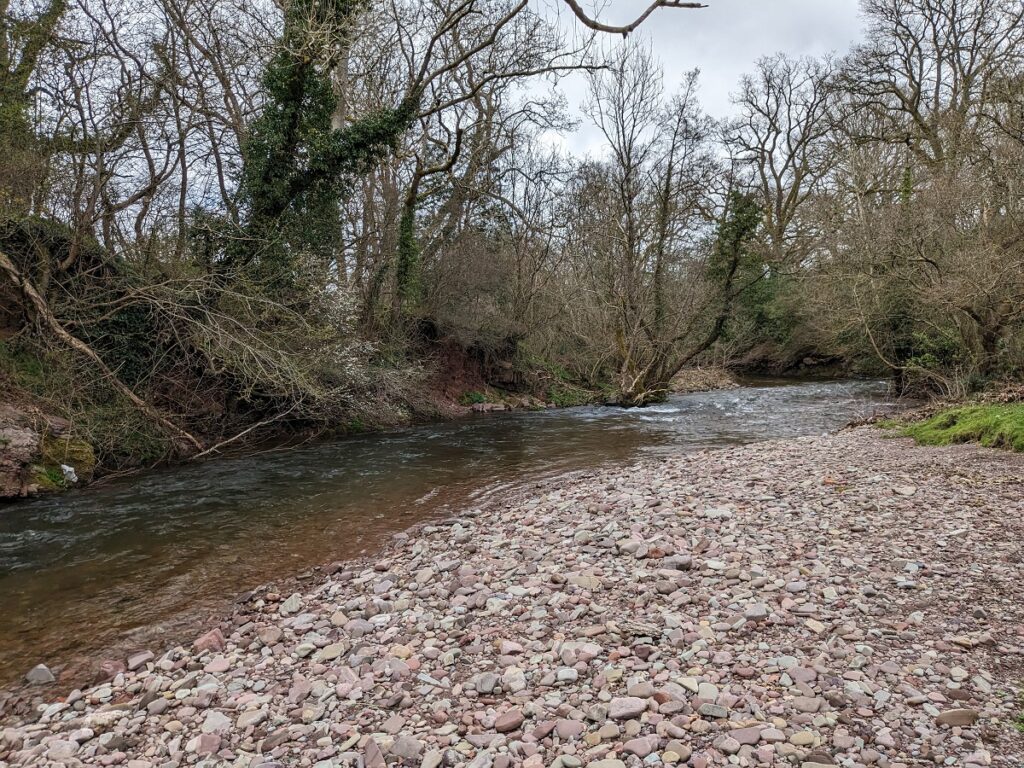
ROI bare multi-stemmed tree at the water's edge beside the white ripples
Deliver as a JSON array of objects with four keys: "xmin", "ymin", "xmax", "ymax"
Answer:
[{"xmin": 569, "ymin": 45, "xmax": 721, "ymax": 404}]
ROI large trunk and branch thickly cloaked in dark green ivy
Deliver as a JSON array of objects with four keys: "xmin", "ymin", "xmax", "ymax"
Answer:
[{"xmin": 223, "ymin": 0, "xmax": 419, "ymax": 294}]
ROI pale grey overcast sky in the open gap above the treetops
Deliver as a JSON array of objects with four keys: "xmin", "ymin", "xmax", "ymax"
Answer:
[{"xmin": 548, "ymin": 0, "xmax": 861, "ymax": 154}]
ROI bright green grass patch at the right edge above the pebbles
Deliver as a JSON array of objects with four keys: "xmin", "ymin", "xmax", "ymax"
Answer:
[{"xmin": 888, "ymin": 402, "xmax": 1024, "ymax": 452}]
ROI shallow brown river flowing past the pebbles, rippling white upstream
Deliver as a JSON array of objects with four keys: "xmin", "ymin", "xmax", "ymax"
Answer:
[{"xmin": 0, "ymin": 381, "xmax": 891, "ymax": 681}]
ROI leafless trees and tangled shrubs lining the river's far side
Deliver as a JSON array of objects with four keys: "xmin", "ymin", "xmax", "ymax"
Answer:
[{"xmin": 0, "ymin": 0, "xmax": 1024, "ymax": 496}]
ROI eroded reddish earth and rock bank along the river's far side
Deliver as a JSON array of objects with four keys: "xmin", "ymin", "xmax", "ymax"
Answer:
[{"xmin": 0, "ymin": 356, "xmax": 739, "ymax": 499}]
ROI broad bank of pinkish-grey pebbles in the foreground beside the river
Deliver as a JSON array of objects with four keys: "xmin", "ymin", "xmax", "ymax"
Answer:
[{"xmin": 0, "ymin": 428, "xmax": 1024, "ymax": 768}]
